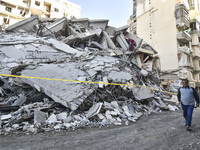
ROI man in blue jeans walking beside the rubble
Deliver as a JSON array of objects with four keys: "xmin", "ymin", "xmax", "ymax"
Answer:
[{"xmin": 178, "ymin": 79, "xmax": 199, "ymax": 131}]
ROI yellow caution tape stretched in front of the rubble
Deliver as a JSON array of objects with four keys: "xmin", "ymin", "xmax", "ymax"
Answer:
[{"xmin": 0, "ymin": 74, "xmax": 177, "ymax": 95}]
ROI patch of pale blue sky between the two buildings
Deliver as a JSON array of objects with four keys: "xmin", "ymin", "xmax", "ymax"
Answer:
[{"xmin": 69, "ymin": 0, "xmax": 133, "ymax": 27}]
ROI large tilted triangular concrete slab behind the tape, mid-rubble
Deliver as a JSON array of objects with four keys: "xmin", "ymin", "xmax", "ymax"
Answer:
[{"xmin": 21, "ymin": 63, "xmax": 95, "ymax": 110}]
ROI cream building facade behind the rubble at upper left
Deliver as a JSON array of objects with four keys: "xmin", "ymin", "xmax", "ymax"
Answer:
[{"xmin": 0, "ymin": 0, "xmax": 81, "ymax": 28}]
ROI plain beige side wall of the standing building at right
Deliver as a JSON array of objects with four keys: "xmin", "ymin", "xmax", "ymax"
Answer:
[{"xmin": 137, "ymin": 0, "xmax": 178, "ymax": 70}]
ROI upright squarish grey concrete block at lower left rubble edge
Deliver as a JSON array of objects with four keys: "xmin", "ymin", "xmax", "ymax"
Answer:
[{"xmin": 34, "ymin": 109, "xmax": 46, "ymax": 124}]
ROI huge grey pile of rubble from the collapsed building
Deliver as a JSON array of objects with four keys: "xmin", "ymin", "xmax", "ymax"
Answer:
[{"xmin": 0, "ymin": 16, "xmax": 178, "ymax": 134}]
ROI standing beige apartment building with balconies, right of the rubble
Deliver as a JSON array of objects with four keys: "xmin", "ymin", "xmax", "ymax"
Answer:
[{"xmin": 128, "ymin": 0, "xmax": 200, "ymax": 90}]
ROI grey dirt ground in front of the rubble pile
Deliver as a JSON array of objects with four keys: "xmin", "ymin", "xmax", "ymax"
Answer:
[{"xmin": 0, "ymin": 108, "xmax": 200, "ymax": 150}]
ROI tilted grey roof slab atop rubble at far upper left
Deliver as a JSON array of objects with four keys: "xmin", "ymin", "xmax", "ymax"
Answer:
[{"xmin": 6, "ymin": 15, "xmax": 39, "ymax": 32}]
